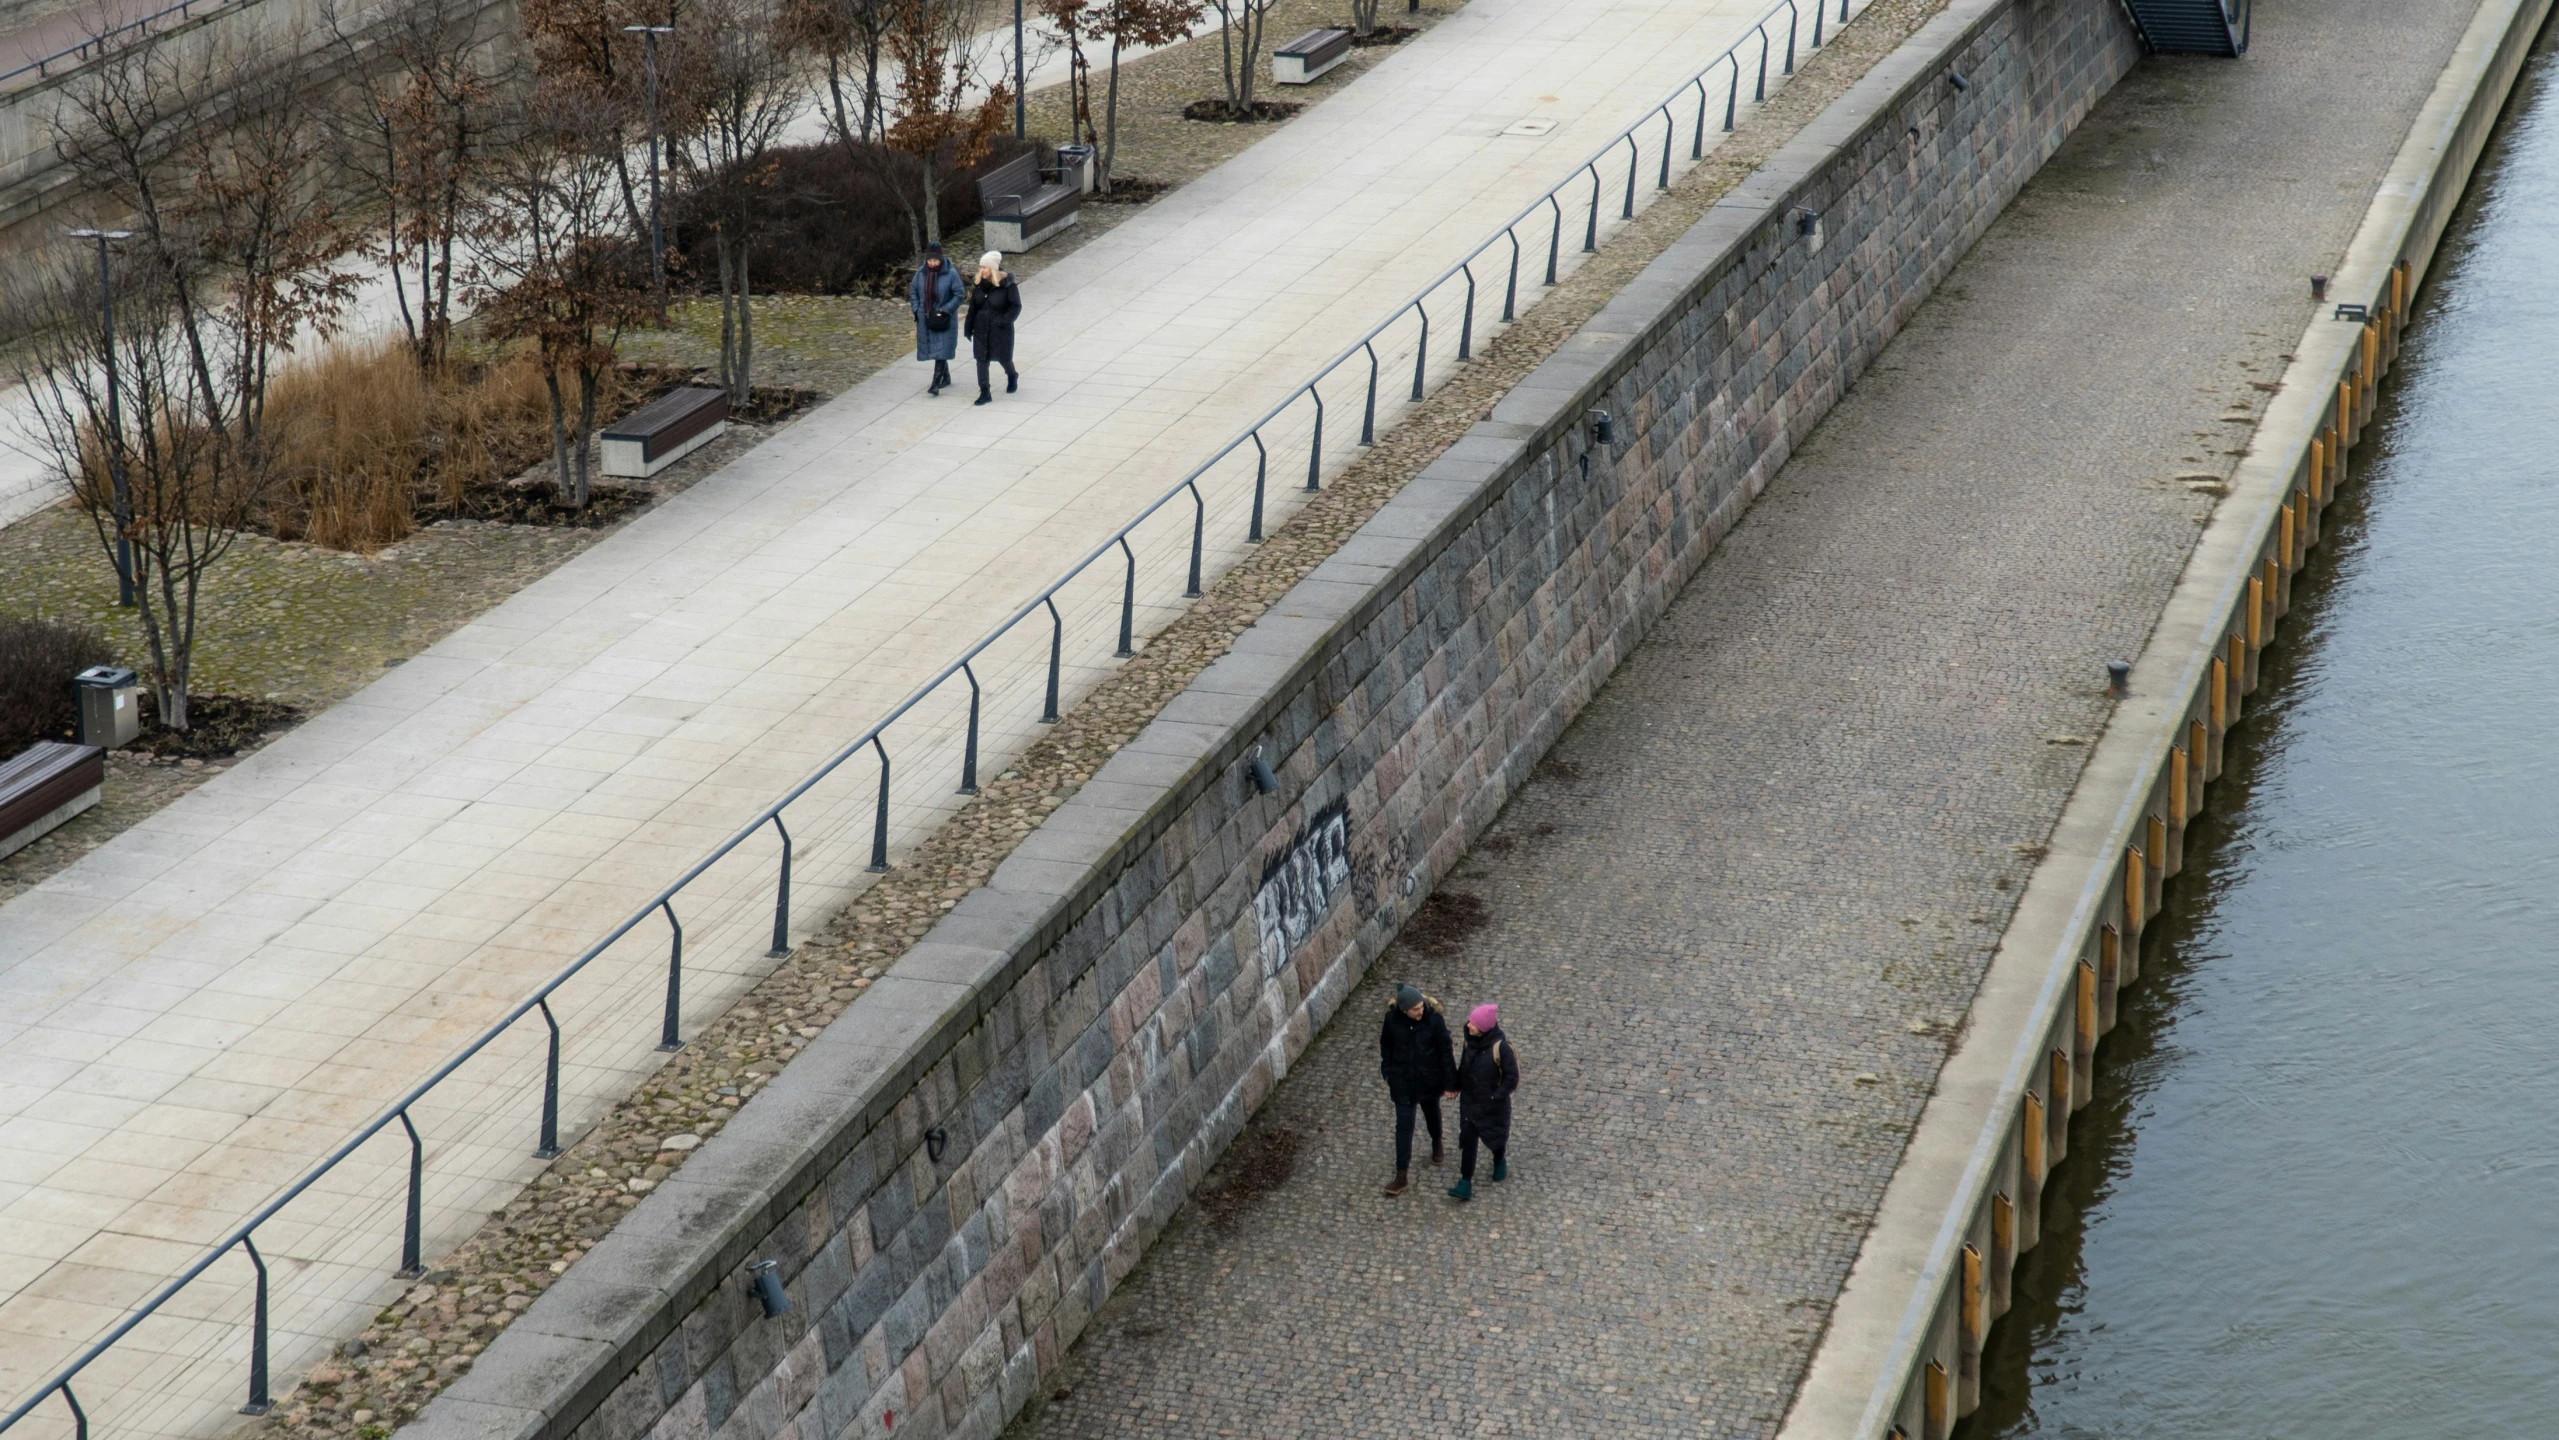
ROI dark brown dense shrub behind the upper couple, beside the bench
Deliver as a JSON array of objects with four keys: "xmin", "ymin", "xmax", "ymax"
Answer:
[{"xmin": 668, "ymin": 136, "xmax": 1039, "ymax": 294}]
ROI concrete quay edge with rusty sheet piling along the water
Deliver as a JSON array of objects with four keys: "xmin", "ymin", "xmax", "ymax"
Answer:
[{"xmin": 1779, "ymin": 0, "xmax": 2551, "ymax": 1440}]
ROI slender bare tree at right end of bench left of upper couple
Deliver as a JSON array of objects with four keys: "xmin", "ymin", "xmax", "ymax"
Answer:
[{"xmin": 670, "ymin": 0, "xmax": 806, "ymax": 407}]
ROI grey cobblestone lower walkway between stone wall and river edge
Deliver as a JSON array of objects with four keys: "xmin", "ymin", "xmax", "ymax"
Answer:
[{"xmin": 1016, "ymin": 0, "xmax": 2472, "ymax": 1440}]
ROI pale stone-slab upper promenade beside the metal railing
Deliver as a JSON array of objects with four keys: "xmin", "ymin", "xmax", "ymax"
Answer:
[{"xmin": 0, "ymin": 0, "xmax": 1822, "ymax": 1435}]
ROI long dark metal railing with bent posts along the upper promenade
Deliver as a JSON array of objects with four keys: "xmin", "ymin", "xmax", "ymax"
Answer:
[{"xmin": 0, "ymin": 0, "xmax": 1850, "ymax": 1437}]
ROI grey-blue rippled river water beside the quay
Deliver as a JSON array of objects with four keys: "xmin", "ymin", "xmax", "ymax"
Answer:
[{"xmin": 1963, "ymin": 36, "xmax": 2559, "ymax": 1440}]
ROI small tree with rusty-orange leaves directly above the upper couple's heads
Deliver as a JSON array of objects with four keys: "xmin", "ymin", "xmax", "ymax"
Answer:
[{"xmin": 883, "ymin": 0, "xmax": 1013, "ymax": 248}]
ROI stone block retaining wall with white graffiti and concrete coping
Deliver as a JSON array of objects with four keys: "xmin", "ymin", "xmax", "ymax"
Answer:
[{"xmin": 409, "ymin": 0, "xmax": 2137, "ymax": 1440}]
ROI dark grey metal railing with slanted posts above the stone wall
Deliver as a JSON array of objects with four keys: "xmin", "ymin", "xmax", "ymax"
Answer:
[{"xmin": 0, "ymin": 0, "xmax": 1850, "ymax": 1440}]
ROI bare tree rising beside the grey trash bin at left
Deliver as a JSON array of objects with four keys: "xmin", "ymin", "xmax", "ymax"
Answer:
[{"xmin": 8, "ymin": 256, "xmax": 269, "ymax": 729}]
